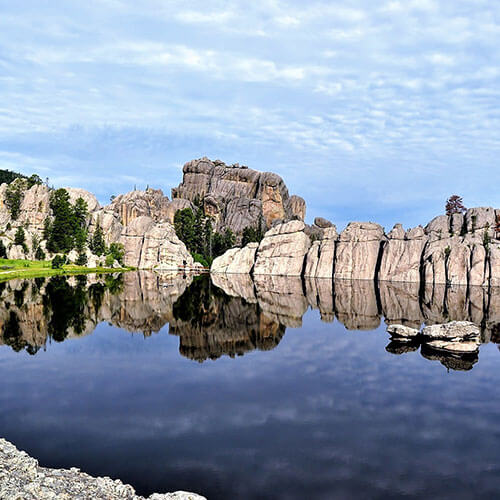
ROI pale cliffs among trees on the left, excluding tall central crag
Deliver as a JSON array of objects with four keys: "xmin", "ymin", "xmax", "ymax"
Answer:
[{"xmin": 0, "ymin": 180, "xmax": 194, "ymax": 269}]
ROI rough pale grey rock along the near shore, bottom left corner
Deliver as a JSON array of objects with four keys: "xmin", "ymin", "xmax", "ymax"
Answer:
[{"xmin": 0, "ymin": 439, "xmax": 206, "ymax": 500}]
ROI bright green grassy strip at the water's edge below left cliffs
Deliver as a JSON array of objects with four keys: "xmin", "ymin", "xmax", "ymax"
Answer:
[{"xmin": 0, "ymin": 259, "xmax": 132, "ymax": 281}]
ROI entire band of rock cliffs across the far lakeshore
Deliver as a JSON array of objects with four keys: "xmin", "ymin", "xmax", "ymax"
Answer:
[{"xmin": 0, "ymin": 158, "xmax": 500, "ymax": 282}]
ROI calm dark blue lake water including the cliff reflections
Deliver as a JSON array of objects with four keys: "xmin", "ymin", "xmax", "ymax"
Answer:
[{"xmin": 0, "ymin": 273, "xmax": 500, "ymax": 499}]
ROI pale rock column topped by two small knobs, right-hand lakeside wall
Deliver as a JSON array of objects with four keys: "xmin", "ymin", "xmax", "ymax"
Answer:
[{"xmin": 378, "ymin": 224, "xmax": 427, "ymax": 282}]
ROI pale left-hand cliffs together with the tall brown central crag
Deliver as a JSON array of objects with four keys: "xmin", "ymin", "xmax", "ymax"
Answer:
[{"xmin": 0, "ymin": 158, "xmax": 306, "ymax": 269}]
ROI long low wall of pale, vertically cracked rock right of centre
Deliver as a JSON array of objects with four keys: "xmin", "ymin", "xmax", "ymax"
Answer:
[{"xmin": 212, "ymin": 207, "xmax": 500, "ymax": 287}]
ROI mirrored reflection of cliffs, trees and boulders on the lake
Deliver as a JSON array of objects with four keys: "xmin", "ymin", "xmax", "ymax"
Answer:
[{"xmin": 0, "ymin": 272, "xmax": 500, "ymax": 369}]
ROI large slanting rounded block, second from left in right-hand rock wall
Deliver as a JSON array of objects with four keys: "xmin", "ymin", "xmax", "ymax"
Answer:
[{"xmin": 253, "ymin": 221, "xmax": 311, "ymax": 276}]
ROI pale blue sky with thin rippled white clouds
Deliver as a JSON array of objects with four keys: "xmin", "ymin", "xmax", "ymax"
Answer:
[{"xmin": 0, "ymin": 0, "xmax": 500, "ymax": 229}]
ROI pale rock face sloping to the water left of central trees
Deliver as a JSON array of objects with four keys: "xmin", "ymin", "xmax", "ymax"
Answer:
[{"xmin": 120, "ymin": 216, "xmax": 194, "ymax": 269}]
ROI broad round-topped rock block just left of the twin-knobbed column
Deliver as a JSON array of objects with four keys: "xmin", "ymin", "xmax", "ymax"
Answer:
[{"xmin": 334, "ymin": 222, "xmax": 386, "ymax": 280}]
